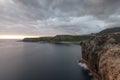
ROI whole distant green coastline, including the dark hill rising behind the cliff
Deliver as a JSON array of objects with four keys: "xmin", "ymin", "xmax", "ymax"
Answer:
[{"xmin": 22, "ymin": 27, "xmax": 120, "ymax": 44}]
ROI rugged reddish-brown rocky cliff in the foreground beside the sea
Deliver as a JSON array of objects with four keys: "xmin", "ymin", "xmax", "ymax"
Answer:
[{"xmin": 81, "ymin": 34, "xmax": 120, "ymax": 80}]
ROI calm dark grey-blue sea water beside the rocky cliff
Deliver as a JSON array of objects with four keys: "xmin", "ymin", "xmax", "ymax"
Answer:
[{"xmin": 0, "ymin": 40, "xmax": 90, "ymax": 80}]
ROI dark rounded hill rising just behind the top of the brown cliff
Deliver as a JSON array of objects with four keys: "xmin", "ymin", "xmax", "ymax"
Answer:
[{"xmin": 98, "ymin": 27, "xmax": 120, "ymax": 35}]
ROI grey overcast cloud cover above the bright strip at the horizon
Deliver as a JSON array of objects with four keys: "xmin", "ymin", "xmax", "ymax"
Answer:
[{"xmin": 0, "ymin": 0, "xmax": 120, "ymax": 35}]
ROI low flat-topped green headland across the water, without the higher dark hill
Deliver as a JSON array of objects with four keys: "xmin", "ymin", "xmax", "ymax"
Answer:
[{"xmin": 23, "ymin": 35, "xmax": 93, "ymax": 43}]
